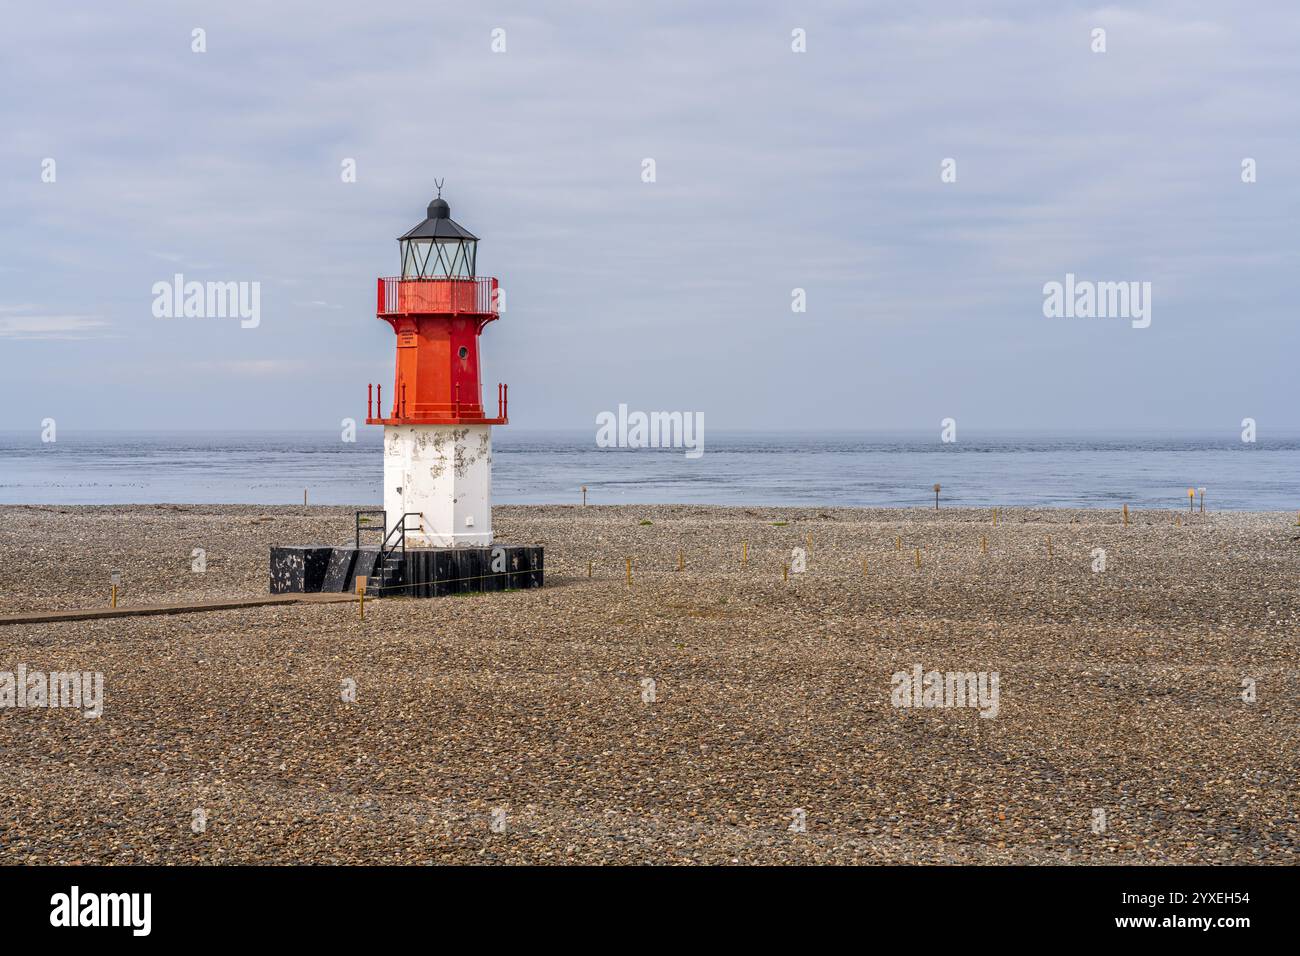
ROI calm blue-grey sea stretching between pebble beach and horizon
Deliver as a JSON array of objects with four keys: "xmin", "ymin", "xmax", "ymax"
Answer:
[{"xmin": 0, "ymin": 428, "xmax": 1300, "ymax": 511}]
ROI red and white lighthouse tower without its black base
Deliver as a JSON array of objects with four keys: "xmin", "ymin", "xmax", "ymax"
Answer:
[{"xmin": 365, "ymin": 187, "xmax": 508, "ymax": 548}]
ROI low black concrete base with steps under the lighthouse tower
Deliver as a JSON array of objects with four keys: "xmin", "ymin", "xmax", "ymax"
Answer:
[{"xmin": 270, "ymin": 545, "xmax": 545, "ymax": 597}]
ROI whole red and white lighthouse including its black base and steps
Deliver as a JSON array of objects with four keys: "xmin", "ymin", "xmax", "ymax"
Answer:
[{"xmin": 270, "ymin": 191, "xmax": 546, "ymax": 606}]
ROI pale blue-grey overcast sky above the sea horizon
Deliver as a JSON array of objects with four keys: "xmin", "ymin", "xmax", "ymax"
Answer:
[{"xmin": 0, "ymin": 0, "xmax": 1300, "ymax": 440}]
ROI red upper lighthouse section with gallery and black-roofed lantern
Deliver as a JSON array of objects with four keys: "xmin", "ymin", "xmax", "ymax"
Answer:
[{"xmin": 365, "ymin": 190, "xmax": 507, "ymax": 425}]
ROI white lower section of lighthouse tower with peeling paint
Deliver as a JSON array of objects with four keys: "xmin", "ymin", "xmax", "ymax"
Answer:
[{"xmin": 384, "ymin": 425, "xmax": 491, "ymax": 548}]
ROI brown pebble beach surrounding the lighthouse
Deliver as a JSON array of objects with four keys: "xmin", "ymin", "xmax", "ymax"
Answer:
[{"xmin": 0, "ymin": 505, "xmax": 1300, "ymax": 865}]
